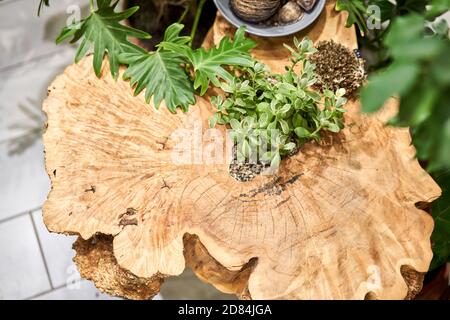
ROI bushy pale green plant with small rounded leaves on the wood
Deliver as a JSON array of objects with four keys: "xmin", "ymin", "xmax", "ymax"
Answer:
[{"xmin": 210, "ymin": 38, "xmax": 347, "ymax": 167}]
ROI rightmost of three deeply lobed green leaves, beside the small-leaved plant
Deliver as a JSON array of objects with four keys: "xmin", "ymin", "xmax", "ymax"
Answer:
[{"xmin": 185, "ymin": 27, "xmax": 256, "ymax": 95}]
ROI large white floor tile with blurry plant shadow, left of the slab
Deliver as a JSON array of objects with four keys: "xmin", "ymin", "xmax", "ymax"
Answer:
[{"xmin": 0, "ymin": 50, "xmax": 73, "ymax": 220}]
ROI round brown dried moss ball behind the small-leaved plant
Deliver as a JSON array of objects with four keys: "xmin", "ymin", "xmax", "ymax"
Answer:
[{"xmin": 309, "ymin": 40, "xmax": 366, "ymax": 98}]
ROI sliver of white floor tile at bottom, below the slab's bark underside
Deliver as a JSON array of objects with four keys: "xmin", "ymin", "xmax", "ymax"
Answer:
[{"xmin": 34, "ymin": 280, "xmax": 119, "ymax": 300}]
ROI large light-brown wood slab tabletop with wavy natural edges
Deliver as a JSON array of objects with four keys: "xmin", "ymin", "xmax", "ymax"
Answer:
[{"xmin": 44, "ymin": 3, "xmax": 440, "ymax": 299}]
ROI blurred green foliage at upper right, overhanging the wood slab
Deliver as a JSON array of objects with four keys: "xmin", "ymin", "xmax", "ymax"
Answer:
[{"xmin": 361, "ymin": 8, "xmax": 450, "ymax": 173}]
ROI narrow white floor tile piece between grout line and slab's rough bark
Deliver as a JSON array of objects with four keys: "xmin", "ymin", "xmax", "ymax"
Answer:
[{"xmin": 33, "ymin": 210, "xmax": 80, "ymax": 287}]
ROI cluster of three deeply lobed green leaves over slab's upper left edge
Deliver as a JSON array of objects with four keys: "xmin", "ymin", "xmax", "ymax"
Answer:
[{"xmin": 54, "ymin": 0, "xmax": 255, "ymax": 112}]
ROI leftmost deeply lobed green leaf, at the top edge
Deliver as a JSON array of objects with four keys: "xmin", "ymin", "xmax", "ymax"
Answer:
[{"xmin": 56, "ymin": 1, "xmax": 150, "ymax": 79}]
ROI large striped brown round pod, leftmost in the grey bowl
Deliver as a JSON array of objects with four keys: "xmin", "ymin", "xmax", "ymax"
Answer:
[{"xmin": 230, "ymin": 0, "xmax": 281, "ymax": 22}]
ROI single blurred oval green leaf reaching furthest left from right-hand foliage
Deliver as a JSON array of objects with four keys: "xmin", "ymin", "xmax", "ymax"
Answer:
[{"xmin": 361, "ymin": 62, "xmax": 420, "ymax": 112}]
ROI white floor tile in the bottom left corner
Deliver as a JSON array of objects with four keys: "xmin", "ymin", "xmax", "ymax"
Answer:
[{"xmin": 0, "ymin": 214, "xmax": 50, "ymax": 300}]
